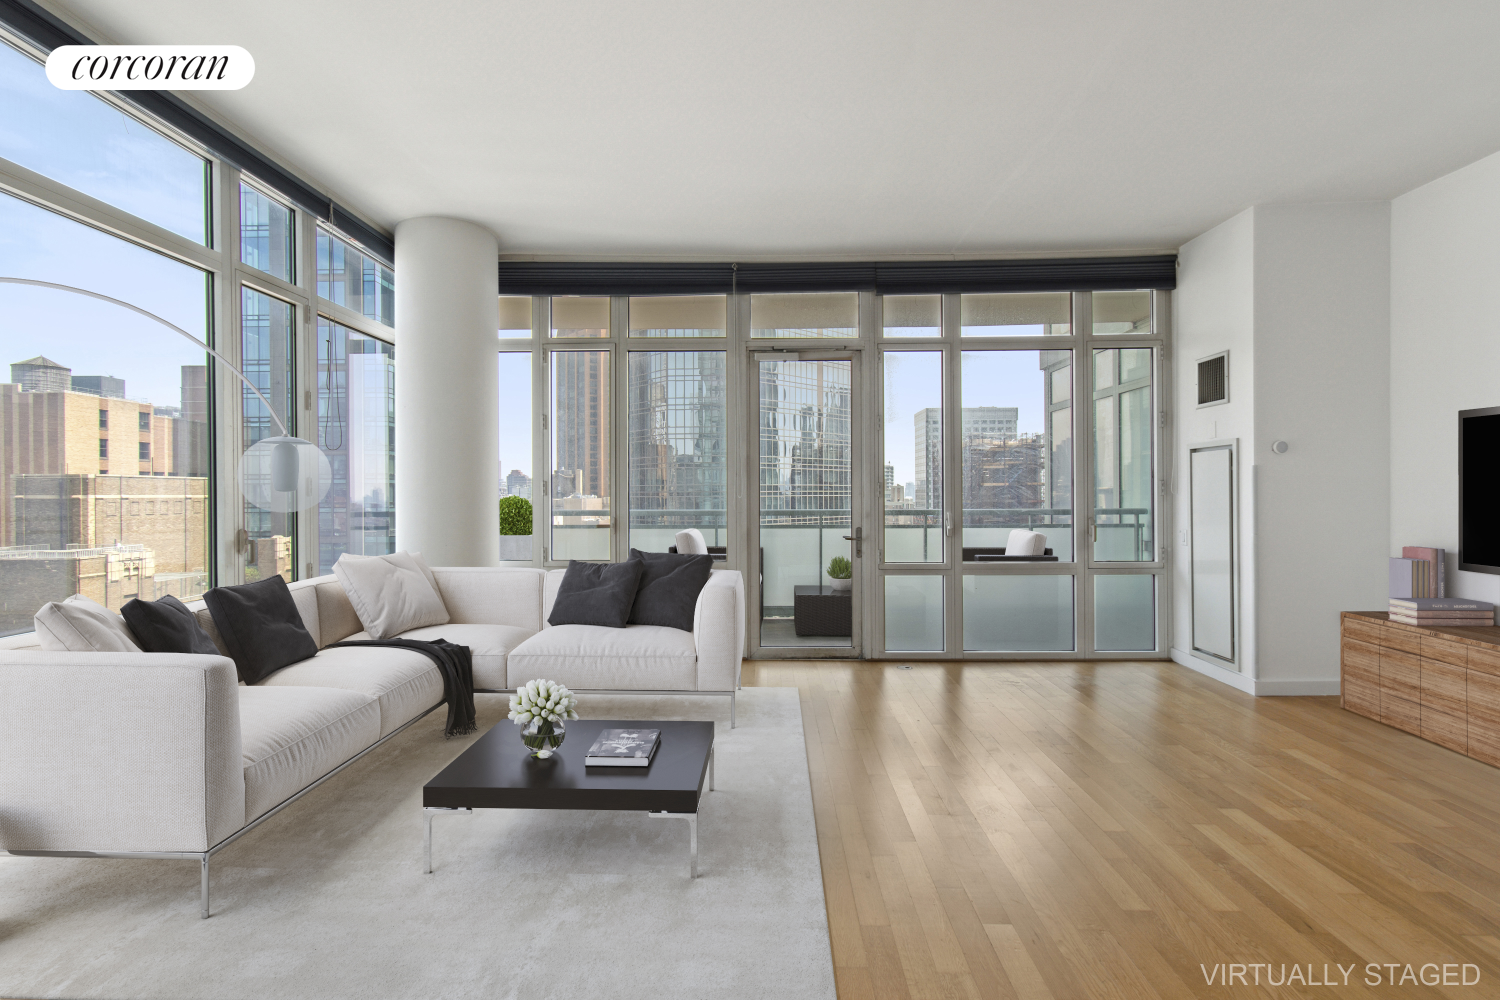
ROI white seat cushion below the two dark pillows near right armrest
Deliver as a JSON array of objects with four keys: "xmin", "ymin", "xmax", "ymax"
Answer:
[{"xmin": 506, "ymin": 625, "xmax": 698, "ymax": 691}]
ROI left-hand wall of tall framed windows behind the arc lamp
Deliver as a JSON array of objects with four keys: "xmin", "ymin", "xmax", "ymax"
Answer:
[{"xmin": 0, "ymin": 34, "xmax": 395, "ymax": 631}]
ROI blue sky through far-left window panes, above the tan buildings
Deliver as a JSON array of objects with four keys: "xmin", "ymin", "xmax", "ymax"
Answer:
[{"xmin": 0, "ymin": 43, "xmax": 207, "ymax": 406}]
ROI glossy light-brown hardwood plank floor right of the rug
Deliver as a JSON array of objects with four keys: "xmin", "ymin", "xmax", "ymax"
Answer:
[{"xmin": 743, "ymin": 661, "xmax": 1500, "ymax": 1000}]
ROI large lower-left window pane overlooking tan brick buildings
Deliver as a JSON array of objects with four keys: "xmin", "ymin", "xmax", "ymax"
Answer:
[{"xmin": 0, "ymin": 193, "xmax": 212, "ymax": 633}]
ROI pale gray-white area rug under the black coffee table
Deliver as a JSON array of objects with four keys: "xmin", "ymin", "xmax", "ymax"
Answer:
[{"xmin": 0, "ymin": 688, "xmax": 834, "ymax": 1000}]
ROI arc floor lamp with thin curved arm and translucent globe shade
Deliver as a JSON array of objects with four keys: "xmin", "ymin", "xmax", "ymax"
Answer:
[{"xmin": 0, "ymin": 277, "xmax": 333, "ymax": 514}]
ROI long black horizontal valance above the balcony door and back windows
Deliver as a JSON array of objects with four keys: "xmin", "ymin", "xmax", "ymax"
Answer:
[{"xmin": 500, "ymin": 253, "xmax": 1178, "ymax": 295}]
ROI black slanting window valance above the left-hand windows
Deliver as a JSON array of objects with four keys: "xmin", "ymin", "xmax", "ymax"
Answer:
[{"xmin": 0, "ymin": 0, "xmax": 396, "ymax": 265}]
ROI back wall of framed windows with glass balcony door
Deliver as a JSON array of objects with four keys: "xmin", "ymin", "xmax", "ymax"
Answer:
[{"xmin": 500, "ymin": 281, "xmax": 1166, "ymax": 658}]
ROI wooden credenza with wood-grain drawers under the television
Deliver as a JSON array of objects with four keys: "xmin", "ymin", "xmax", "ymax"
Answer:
[{"xmin": 1340, "ymin": 612, "xmax": 1500, "ymax": 766}]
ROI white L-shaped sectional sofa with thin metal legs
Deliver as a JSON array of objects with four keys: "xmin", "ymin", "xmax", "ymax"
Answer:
[{"xmin": 0, "ymin": 567, "xmax": 744, "ymax": 916}]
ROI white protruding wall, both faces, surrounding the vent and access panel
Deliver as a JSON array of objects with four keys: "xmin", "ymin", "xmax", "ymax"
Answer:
[{"xmin": 1173, "ymin": 202, "xmax": 1391, "ymax": 694}]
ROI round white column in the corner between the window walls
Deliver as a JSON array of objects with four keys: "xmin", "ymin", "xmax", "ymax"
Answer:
[{"xmin": 396, "ymin": 217, "xmax": 500, "ymax": 565}]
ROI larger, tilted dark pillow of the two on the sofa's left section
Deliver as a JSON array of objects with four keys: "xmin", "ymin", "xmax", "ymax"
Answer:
[{"xmin": 203, "ymin": 574, "xmax": 318, "ymax": 684}]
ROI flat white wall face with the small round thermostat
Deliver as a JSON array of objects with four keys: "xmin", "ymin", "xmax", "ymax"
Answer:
[{"xmin": 1247, "ymin": 201, "xmax": 1391, "ymax": 694}]
